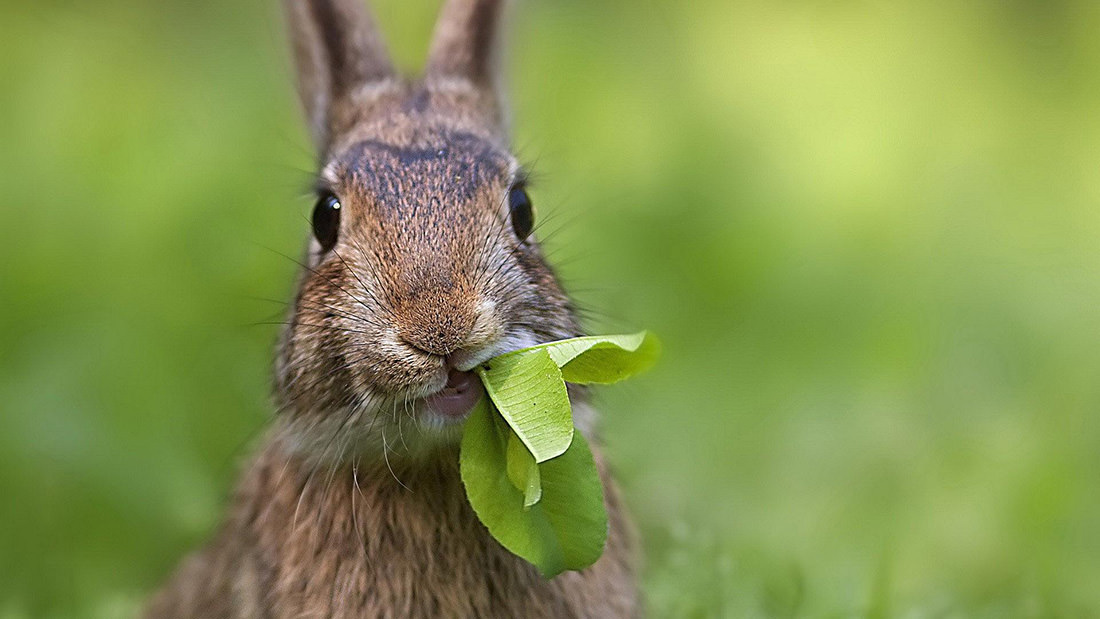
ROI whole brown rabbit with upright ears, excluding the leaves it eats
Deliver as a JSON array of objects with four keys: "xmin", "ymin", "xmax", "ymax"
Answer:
[{"xmin": 145, "ymin": 0, "xmax": 640, "ymax": 618}]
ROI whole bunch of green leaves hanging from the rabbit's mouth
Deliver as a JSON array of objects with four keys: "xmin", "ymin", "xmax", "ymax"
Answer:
[{"xmin": 460, "ymin": 331, "xmax": 660, "ymax": 578}]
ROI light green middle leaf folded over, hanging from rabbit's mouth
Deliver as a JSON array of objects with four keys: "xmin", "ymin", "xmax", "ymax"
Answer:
[{"xmin": 477, "ymin": 349, "xmax": 573, "ymax": 463}]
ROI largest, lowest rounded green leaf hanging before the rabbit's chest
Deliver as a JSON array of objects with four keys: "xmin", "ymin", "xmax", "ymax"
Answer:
[{"xmin": 461, "ymin": 400, "xmax": 607, "ymax": 578}]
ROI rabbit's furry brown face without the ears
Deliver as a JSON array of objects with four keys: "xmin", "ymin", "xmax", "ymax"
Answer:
[{"xmin": 276, "ymin": 87, "xmax": 579, "ymax": 461}]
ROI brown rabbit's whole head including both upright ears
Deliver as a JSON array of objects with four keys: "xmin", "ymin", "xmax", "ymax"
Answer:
[{"xmin": 276, "ymin": 0, "xmax": 579, "ymax": 460}]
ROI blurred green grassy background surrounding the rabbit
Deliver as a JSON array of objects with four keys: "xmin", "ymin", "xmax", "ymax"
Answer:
[{"xmin": 0, "ymin": 0, "xmax": 1100, "ymax": 619}]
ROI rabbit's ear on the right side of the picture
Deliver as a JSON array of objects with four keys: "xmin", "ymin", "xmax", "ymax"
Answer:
[{"xmin": 427, "ymin": 0, "xmax": 506, "ymax": 99}]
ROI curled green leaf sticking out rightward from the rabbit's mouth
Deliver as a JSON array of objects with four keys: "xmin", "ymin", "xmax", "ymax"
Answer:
[{"xmin": 492, "ymin": 331, "xmax": 661, "ymax": 385}]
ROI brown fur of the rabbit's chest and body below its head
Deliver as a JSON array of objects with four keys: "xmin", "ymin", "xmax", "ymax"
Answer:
[{"xmin": 147, "ymin": 428, "xmax": 636, "ymax": 619}]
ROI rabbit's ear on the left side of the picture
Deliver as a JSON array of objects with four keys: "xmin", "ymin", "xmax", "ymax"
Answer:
[{"xmin": 284, "ymin": 0, "xmax": 394, "ymax": 153}]
